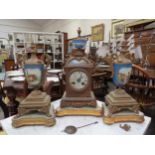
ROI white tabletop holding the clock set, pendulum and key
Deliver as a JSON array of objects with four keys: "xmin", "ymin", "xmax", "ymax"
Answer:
[{"xmin": 0, "ymin": 100, "xmax": 151, "ymax": 135}]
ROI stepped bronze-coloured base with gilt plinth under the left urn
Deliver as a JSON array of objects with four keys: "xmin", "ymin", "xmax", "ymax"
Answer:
[{"xmin": 12, "ymin": 90, "xmax": 56, "ymax": 128}]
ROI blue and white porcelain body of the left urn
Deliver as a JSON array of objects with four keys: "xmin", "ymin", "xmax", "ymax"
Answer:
[{"xmin": 24, "ymin": 64, "xmax": 44, "ymax": 88}]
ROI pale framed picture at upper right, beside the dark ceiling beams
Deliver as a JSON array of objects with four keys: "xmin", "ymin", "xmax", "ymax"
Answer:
[{"xmin": 111, "ymin": 19, "xmax": 125, "ymax": 38}]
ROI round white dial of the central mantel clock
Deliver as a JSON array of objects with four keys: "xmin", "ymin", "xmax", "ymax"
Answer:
[{"xmin": 69, "ymin": 71, "xmax": 88, "ymax": 90}]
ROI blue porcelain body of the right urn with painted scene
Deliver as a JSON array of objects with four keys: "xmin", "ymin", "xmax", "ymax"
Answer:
[{"xmin": 113, "ymin": 63, "xmax": 132, "ymax": 87}]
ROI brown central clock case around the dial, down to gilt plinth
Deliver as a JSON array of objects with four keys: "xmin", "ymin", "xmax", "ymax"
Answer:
[{"xmin": 56, "ymin": 49, "xmax": 103, "ymax": 116}]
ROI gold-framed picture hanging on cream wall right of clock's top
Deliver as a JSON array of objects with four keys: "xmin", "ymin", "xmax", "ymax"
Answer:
[{"xmin": 91, "ymin": 24, "xmax": 104, "ymax": 42}]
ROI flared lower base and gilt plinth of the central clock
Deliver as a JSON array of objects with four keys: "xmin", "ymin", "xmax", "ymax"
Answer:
[{"xmin": 56, "ymin": 92, "xmax": 103, "ymax": 117}]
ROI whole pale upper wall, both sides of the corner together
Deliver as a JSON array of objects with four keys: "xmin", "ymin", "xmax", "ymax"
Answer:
[{"xmin": 0, "ymin": 19, "xmax": 111, "ymax": 42}]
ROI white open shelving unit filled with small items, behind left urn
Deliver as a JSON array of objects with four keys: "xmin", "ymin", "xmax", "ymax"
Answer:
[{"xmin": 13, "ymin": 32, "xmax": 64, "ymax": 68}]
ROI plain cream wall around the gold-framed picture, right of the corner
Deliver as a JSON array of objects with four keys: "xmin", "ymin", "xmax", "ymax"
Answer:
[{"xmin": 42, "ymin": 19, "xmax": 111, "ymax": 42}]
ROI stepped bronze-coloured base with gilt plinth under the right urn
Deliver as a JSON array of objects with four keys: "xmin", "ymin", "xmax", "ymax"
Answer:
[{"xmin": 103, "ymin": 89, "xmax": 144, "ymax": 125}]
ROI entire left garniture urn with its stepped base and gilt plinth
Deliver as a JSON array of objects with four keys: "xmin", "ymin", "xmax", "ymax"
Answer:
[{"xmin": 12, "ymin": 55, "xmax": 56, "ymax": 128}]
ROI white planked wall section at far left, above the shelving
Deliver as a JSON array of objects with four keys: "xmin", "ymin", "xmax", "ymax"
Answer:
[{"xmin": 0, "ymin": 19, "xmax": 41, "ymax": 38}]
